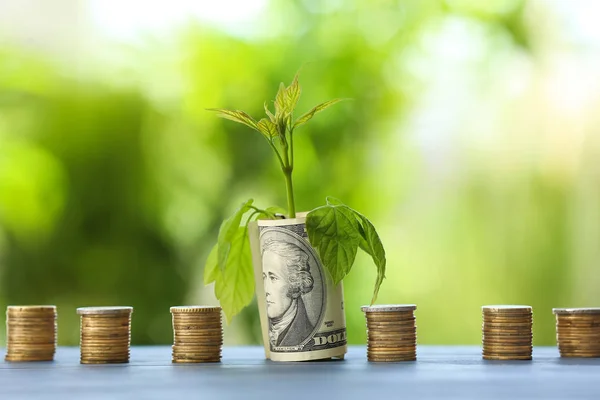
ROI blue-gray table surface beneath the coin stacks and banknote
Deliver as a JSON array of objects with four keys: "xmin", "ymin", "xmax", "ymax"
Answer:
[{"xmin": 0, "ymin": 346, "xmax": 600, "ymax": 400}]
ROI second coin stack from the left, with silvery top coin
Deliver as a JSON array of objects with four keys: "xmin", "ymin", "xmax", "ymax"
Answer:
[{"xmin": 77, "ymin": 307, "xmax": 133, "ymax": 364}]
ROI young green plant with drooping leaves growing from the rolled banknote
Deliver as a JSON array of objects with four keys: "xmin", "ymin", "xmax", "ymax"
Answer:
[{"xmin": 204, "ymin": 74, "xmax": 386, "ymax": 320}]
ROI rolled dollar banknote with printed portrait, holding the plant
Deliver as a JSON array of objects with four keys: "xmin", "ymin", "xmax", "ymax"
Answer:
[{"xmin": 249, "ymin": 214, "xmax": 347, "ymax": 361}]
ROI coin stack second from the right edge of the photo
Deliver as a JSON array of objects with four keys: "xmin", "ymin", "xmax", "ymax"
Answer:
[{"xmin": 482, "ymin": 306, "xmax": 533, "ymax": 360}]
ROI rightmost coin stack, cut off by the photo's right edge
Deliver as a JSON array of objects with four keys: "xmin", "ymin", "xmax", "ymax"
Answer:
[{"xmin": 552, "ymin": 308, "xmax": 600, "ymax": 357}]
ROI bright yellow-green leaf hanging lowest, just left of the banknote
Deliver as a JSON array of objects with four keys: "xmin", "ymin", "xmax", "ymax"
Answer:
[{"xmin": 215, "ymin": 226, "xmax": 254, "ymax": 322}]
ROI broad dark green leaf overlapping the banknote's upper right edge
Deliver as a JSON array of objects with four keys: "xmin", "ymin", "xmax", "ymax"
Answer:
[{"xmin": 306, "ymin": 205, "xmax": 361, "ymax": 285}]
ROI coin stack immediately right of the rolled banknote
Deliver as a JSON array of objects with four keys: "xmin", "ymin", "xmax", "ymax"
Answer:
[{"xmin": 361, "ymin": 304, "xmax": 417, "ymax": 362}]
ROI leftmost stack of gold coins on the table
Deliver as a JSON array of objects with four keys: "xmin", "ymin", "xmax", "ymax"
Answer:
[{"xmin": 5, "ymin": 306, "xmax": 56, "ymax": 361}]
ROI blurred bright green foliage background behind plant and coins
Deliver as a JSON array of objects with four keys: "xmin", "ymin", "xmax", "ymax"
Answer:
[{"xmin": 0, "ymin": 0, "xmax": 600, "ymax": 345}]
